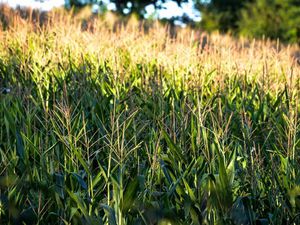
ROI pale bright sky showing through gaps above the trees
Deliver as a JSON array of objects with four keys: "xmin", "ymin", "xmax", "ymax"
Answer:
[{"xmin": 0, "ymin": 0, "xmax": 200, "ymax": 21}]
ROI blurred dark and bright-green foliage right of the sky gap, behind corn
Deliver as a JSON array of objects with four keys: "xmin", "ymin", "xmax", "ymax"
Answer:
[{"xmin": 196, "ymin": 0, "xmax": 300, "ymax": 43}]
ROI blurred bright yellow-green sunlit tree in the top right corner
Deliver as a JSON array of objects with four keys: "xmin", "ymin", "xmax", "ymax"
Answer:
[{"xmin": 238, "ymin": 0, "xmax": 300, "ymax": 43}]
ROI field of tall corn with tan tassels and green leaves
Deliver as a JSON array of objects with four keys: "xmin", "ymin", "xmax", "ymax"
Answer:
[{"xmin": 0, "ymin": 3, "xmax": 300, "ymax": 225}]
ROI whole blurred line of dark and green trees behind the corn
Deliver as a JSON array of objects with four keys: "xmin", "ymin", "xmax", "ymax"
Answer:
[{"xmin": 64, "ymin": 0, "xmax": 300, "ymax": 44}]
